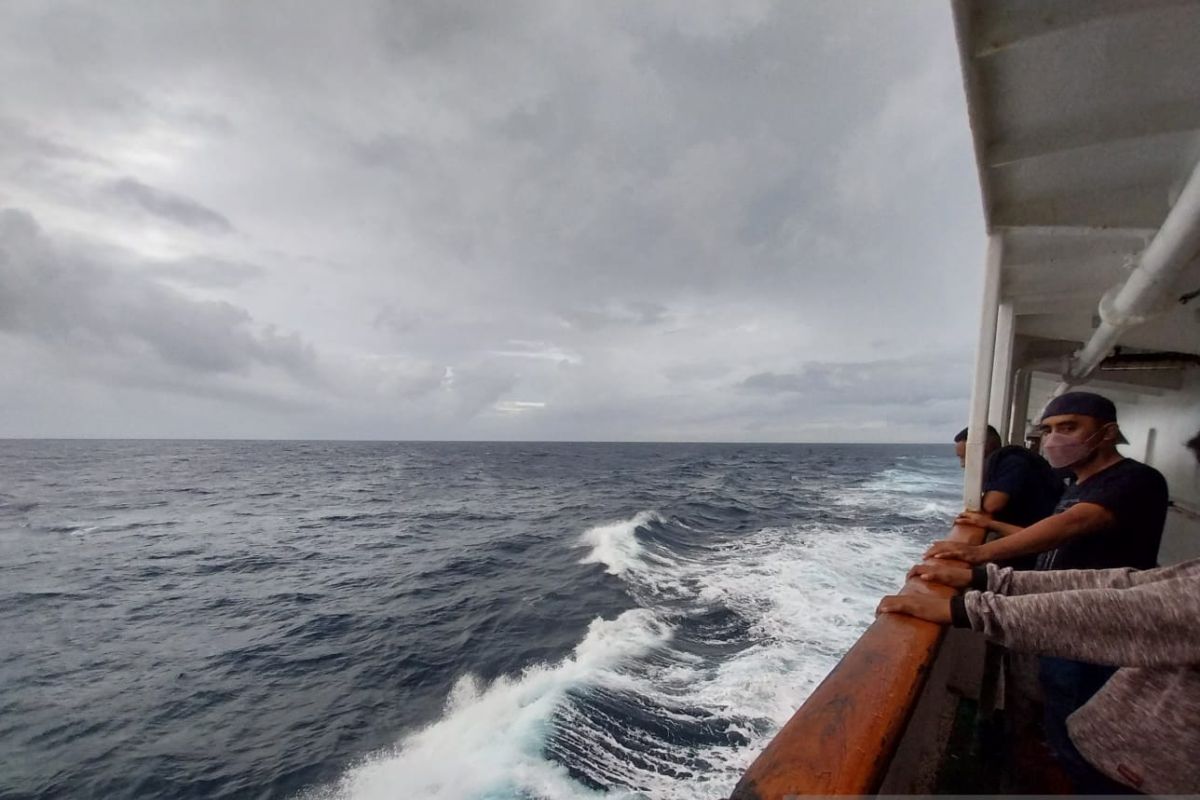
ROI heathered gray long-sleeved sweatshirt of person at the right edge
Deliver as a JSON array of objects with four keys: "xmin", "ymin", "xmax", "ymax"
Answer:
[{"xmin": 952, "ymin": 559, "xmax": 1200, "ymax": 794}]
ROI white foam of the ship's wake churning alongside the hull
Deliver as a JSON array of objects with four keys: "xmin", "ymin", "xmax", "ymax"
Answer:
[{"xmin": 326, "ymin": 475, "xmax": 943, "ymax": 800}]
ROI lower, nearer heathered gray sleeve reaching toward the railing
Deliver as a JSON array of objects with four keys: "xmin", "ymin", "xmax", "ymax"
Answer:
[{"xmin": 962, "ymin": 570, "xmax": 1200, "ymax": 667}]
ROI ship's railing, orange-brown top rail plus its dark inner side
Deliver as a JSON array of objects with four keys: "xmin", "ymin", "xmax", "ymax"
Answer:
[{"xmin": 731, "ymin": 525, "xmax": 984, "ymax": 800}]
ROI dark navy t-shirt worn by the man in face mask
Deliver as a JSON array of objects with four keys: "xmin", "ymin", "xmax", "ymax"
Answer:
[{"xmin": 1038, "ymin": 458, "xmax": 1168, "ymax": 570}]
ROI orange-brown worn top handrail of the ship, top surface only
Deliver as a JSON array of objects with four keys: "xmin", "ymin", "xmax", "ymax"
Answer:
[{"xmin": 731, "ymin": 525, "xmax": 984, "ymax": 800}]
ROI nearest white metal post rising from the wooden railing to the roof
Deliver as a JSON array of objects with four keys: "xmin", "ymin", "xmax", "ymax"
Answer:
[{"xmin": 962, "ymin": 234, "xmax": 1004, "ymax": 511}]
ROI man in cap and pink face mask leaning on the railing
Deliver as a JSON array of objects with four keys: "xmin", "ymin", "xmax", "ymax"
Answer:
[{"xmin": 925, "ymin": 392, "xmax": 1168, "ymax": 782}]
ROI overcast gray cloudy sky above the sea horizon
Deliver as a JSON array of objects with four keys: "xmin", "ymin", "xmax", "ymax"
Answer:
[{"xmin": 0, "ymin": 0, "xmax": 985, "ymax": 441}]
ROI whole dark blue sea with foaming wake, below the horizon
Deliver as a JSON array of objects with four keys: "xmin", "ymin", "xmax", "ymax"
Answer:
[{"xmin": 0, "ymin": 441, "xmax": 960, "ymax": 800}]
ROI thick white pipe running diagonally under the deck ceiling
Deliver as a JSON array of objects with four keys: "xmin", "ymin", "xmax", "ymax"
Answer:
[{"xmin": 1056, "ymin": 162, "xmax": 1200, "ymax": 383}]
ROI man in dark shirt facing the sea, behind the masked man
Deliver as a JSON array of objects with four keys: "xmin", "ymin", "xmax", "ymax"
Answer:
[{"xmin": 954, "ymin": 425, "xmax": 1063, "ymax": 570}]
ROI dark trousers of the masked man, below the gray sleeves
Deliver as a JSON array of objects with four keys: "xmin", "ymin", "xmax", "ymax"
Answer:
[{"xmin": 1038, "ymin": 657, "xmax": 1135, "ymax": 794}]
